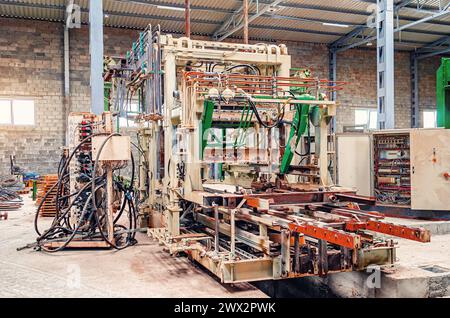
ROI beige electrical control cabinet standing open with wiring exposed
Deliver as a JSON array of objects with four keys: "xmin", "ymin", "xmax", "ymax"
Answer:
[{"xmin": 337, "ymin": 128, "xmax": 450, "ymax": 211}]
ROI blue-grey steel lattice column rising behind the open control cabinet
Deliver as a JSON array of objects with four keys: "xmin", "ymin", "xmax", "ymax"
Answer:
[{"xmin": 377, "ymin": 0, "xmax": 395, "ymax": 129}]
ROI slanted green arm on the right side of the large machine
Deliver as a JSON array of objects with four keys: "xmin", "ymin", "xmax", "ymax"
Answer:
[{"xmin": 280, "ymin": 94, "xmax": 316, "ymax": 174}]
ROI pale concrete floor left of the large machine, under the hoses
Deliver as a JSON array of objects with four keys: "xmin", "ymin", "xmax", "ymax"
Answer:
[{"xmin": 0, "ymin": 197, "xmax": 267, "ymax": 298}]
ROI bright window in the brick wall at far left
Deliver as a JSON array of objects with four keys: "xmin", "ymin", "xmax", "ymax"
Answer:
[{"xmin": 0, "ymin": 99, "xmax": 35, "ymax": 126}]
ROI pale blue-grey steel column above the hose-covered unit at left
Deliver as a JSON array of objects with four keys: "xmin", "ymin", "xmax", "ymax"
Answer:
[{"xmin": 89, "ymin": 0, "xmax": 104, "ymax": 115}]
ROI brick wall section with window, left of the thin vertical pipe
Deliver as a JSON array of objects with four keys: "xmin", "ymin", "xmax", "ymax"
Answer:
[{"xmin": 0, "ymin": 19, "xmax": 64, "ymax": 174}]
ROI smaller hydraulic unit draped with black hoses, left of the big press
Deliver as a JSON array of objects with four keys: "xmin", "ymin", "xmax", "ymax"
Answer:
[{"xmin": 35, "ymin": 112, "xmax": 137, "ymax": 252}]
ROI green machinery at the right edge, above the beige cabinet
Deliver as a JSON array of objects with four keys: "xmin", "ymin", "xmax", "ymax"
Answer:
[{"xmin": 436, "ymin": 58, "xmax": 450, "ymax": 129}]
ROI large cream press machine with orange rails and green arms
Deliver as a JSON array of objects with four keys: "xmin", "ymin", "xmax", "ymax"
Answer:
[{"xmin": 103, "ymin": 26, "xmax": 430, "ymax": 283}]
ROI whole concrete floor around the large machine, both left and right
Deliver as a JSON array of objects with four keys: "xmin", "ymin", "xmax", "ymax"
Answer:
[{"xmin": 0, "ymin": 194, "xmax": 450, "ymax": 298}]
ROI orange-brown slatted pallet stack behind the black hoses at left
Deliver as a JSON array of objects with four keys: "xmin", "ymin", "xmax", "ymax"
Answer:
[{"xmin": 36, "ymin": 175, "xmax": 58, "ymax": 217}]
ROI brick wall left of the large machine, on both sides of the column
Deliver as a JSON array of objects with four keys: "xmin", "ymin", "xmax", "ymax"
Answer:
[{"xmin": 0, "ymin": 18, "xmax": 136, "ymax": 175}]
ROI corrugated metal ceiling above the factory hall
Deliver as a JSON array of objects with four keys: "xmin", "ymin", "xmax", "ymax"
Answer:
[{"xmin": 0, "ymin": 0, "xmax": 450, "ymax": 49}]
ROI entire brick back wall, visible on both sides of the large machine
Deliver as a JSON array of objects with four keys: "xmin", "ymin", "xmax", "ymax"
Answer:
[{"xmin": 0, "ymin": 18, "xmax": 439, "ymax": 174}]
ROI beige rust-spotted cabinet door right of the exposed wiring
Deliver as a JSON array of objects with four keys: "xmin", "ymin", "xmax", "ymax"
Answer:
[{"xmin": 411, "ymin": 129, "xmax": 450, "ymax": 210}]
